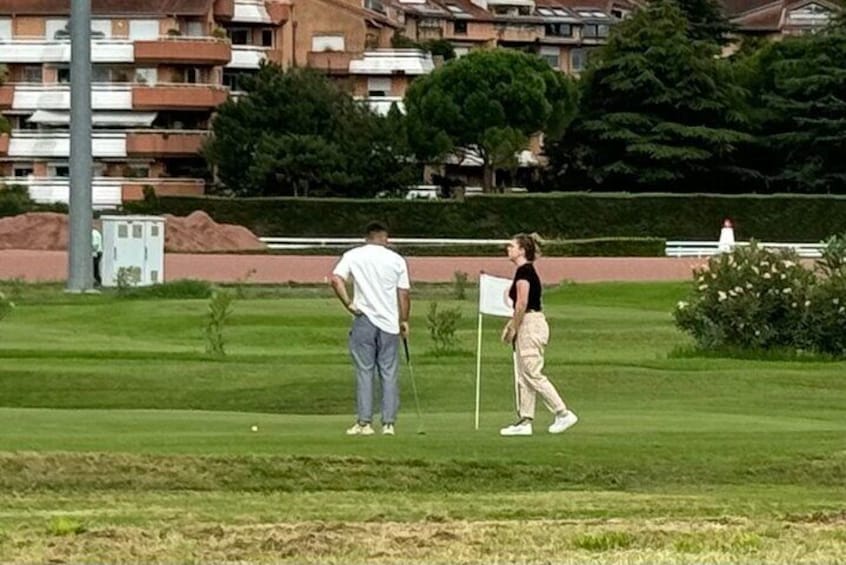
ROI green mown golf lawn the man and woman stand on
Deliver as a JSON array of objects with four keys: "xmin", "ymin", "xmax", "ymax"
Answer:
[{"xmin": 0, "ymin": 283, "xmax": 846, "ymax": 563}]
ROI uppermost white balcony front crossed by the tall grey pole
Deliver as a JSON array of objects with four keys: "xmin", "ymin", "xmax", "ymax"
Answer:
[{"xmin": 0, "ymin": 39, "xmax": 135, "ymax": 64}]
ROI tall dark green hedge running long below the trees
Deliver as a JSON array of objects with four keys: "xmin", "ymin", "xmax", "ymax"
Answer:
[{"xmin": 127, "ymin": 193, "xmax": 846, "ymax": 242}]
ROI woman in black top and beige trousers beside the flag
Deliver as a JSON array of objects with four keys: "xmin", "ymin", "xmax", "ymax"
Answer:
[{"xmin": 500, "ymin": 234, "xmax": 579, "ymax": 436}]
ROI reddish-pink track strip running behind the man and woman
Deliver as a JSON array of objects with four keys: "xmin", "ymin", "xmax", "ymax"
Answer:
[{"xmin": 0, "ymin": 249, "xmax": 706, "ymax": 284}]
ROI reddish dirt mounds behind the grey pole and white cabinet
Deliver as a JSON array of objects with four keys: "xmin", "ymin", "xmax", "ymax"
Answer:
[{"xmin": 0, "ymin": 212, "xmax": 265, "ymax": 253}]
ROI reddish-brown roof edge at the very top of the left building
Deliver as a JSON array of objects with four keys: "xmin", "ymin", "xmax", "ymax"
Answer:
[{"xmin": 0, "ymin": 0, "xmax": 214, "ymax": 16}]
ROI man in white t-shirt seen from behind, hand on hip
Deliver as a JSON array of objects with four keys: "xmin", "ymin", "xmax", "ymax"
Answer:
[{"xmin": 332, "ymin": 222, "xmax": 411, "ymax": 435}]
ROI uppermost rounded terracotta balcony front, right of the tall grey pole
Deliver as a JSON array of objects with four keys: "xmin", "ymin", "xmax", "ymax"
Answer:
[{"xmin": 135, "ymin": 36, "xmax": 232, "ymax": 65}]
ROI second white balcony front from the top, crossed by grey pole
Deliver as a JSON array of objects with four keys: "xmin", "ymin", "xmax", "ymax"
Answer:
[{"xmin": 7, "ymin": 83, "xmax": 132, "ymax": 112}]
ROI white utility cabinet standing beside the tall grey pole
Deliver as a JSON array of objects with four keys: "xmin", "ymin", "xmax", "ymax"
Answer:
[{"xmin": 100, "ymin": 216, "xmax": 165, "ymax": 286}]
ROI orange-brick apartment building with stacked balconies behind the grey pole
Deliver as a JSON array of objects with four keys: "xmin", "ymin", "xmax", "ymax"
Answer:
[{"xmin": 0, "ymin": 0, "xmax": 433, "ymax": 208}]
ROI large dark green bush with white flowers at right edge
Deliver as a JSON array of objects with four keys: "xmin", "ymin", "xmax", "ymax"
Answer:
[{"xmin": 674, "ymin": 238, "xmax": 846, "ymax": 355}]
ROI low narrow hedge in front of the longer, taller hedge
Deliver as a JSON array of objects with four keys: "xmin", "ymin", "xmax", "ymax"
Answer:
[{"xmin": 258, "ymin": 237, "xmax": 666, "ymax": 257}]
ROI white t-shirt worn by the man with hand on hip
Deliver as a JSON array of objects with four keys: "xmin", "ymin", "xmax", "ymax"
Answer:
[{"xmin": 332, "ymin": 243, "xmax": 411, "ymax": 334}]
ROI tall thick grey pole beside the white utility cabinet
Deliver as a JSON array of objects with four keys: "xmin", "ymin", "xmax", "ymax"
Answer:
[{"xmin": 66, "ymin": 0, "xmax": 94, "ymax": 292}]
